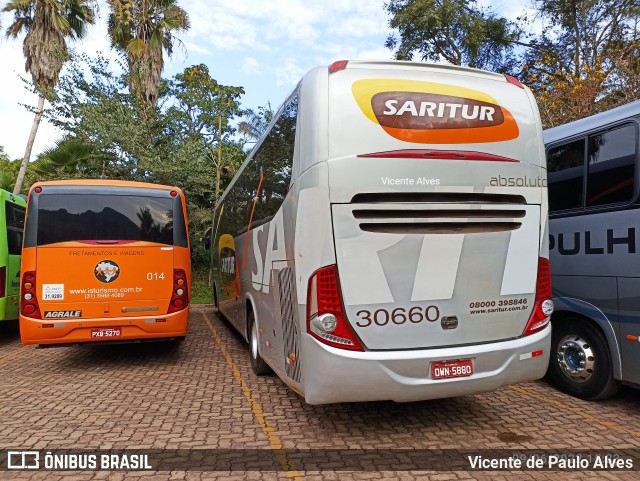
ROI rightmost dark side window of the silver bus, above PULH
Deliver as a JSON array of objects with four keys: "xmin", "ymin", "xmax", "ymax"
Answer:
[{"xmin": 587, "ymin": 124, "xmax": 638, "ymax": 207}]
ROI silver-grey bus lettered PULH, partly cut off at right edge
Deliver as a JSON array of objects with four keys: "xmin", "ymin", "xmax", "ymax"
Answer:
[{"xmin": 544, "ymin": 101, "xmax": 640, "ymax": 400}]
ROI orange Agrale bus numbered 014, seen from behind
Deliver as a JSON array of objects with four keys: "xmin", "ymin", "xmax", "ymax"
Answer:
[{"xmin": 20, "ymin": 180, "xmax": 191, "ymax": 346}]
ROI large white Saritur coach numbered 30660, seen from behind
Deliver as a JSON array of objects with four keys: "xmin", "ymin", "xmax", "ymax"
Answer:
[{"xmin": 208, "ymin": 61, "xmax": 552, "ymax": 404}]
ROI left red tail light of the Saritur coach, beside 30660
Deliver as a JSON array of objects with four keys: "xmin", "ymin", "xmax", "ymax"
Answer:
[{"xmin": 307, "ymin": 265, "xmax": 364, "ymax": 351}]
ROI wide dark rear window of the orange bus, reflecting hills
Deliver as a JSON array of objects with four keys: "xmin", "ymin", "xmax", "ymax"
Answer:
[{"xmin": 37, "ymin": 194, "xmax": 173, "ymax": 245}]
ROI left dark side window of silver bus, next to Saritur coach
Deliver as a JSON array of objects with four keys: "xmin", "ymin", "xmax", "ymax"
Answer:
[{"xmin": 547, "ymin": 139, "xmax": 585, "ymax": 211}]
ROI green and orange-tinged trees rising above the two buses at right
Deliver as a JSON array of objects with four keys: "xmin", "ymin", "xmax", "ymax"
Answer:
[{"xmin": 386, "ymin": 0, "xmax": 640, "ymax": 127}]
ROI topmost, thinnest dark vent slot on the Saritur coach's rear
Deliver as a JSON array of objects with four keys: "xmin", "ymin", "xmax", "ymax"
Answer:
[{"xmin": 351, "ymin": 192, "xmax": 526, "ymax": 205}]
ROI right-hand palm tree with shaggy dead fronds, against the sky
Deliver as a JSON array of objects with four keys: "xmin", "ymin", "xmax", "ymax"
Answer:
[{"xmin": 108, "ymin": 0, "xmax": 189, "ymax": 106}]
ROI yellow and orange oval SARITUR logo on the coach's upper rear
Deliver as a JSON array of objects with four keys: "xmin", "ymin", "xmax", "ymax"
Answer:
[{"xmin": 352, "ymin": 79, "xmax": 519, "ymax": 144}]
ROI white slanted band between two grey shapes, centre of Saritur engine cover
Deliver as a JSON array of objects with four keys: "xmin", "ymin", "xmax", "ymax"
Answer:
[{"xmin": 411, "ymin": 234, "xmax": 464, "ymax": 301}]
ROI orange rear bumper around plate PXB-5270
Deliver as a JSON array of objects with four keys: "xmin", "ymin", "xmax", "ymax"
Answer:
[{"xmin": 20, "ymin": 307, "xmax": 189, "ymax": 345}]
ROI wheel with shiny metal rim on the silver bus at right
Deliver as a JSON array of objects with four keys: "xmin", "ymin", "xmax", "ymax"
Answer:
[{"xmin": 549, "ymin": 319, "xmax": 620, "ymax": 401}]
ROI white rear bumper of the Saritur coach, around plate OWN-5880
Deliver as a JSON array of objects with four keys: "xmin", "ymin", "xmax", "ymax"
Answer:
[{"xmin": 302, "ymin": 326, "xmax": 551, "ymax": 404}]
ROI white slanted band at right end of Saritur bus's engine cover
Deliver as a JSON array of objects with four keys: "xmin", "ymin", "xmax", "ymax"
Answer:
[{"xmin": 500, "ymin": 205, "xmax": 540, "ymax": 296}]
